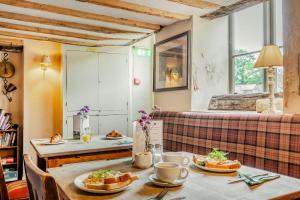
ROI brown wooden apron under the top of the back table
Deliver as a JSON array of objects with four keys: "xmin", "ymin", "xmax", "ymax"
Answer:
[{"xmin": 48, "ymin": 149, "xmax": 132, "ymax": 168}]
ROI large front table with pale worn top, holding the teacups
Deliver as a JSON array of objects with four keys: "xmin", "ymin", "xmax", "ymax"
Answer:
[{"xmin": 48, "ymin": 153, "xmax": 300, "ymax": 200}]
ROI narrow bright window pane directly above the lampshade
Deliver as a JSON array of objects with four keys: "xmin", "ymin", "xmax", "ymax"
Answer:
[{"xmin": 275, "ymin": 0, "xmax": 283, "ymax": 46}]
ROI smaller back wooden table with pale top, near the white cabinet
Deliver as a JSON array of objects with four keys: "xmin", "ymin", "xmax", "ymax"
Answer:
[{"xmin": 30, "ymin": 136, "xmax": 132, "ymax": 171}]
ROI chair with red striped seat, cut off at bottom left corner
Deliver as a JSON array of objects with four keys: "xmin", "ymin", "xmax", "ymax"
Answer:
[{"xmin": 0, "ymin": 158, "xmax": 29, "ymax": 200}]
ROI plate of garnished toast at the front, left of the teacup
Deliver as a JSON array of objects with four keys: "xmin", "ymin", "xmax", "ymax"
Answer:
[{"xmin": 74, "ymin": 169, "xmax": 138, "ymax": 194}]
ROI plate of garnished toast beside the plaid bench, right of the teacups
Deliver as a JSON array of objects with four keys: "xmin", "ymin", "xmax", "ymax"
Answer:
[{"xmin": 193, "ymin": 149, "xmax": 241, "ymax": 173}]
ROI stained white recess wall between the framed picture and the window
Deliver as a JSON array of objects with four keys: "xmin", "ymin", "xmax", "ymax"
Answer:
[{"xmin": 191, "ymin": 17, "xmax": 229, "ymax": 111}]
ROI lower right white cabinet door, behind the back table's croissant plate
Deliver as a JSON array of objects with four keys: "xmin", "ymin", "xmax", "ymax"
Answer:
[{"xmin": 99, "ymin": 115, "xmax": 128, "ymax": 135}]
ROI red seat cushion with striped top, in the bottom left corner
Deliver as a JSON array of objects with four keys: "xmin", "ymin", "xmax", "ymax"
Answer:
[{"xmin": 7, "ymin": 180, "xmax": 29, "ymax": 200}]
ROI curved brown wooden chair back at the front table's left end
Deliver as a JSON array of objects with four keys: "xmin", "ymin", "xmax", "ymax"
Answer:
[{"xmin": 24, "ymin": 154, "xmax": 59, "ymax": 200}]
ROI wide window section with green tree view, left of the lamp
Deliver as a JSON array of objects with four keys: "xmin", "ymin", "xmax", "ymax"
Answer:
[{"xmin": 233, "ymin": 4, "xmax": 264, "ymax": 94}]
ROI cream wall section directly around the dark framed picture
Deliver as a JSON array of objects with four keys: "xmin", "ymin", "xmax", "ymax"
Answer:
[{"xmin": 154, "ymin": 20, "xmax": 193, "ymax": 111}]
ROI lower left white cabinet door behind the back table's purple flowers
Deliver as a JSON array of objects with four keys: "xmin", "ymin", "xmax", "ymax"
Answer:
[{"xmin": 64, "ymin": 115, "xmax": 99, "ymax": 138}]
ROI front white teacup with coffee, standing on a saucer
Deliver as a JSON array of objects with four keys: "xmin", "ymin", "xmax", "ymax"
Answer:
[{"xmin": 154, "ymin": 162, "xmax": 189, "ymax": 183}]
